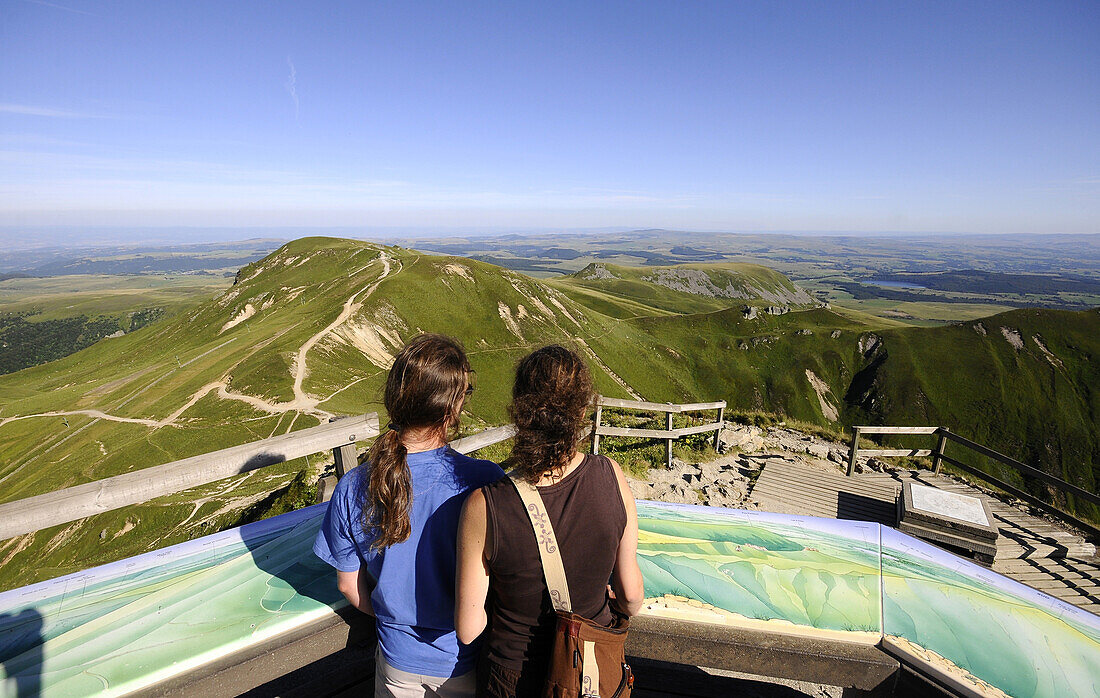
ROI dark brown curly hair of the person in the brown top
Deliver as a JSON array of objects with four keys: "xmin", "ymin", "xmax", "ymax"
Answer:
[{"xmin": 508, "ymin": 344, "xmax": 595, "ymax": 484}]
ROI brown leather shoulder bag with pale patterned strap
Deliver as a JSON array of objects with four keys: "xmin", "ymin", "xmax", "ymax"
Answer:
[{"xmin": 512, "ymin": 475, "xmax": 634, "ymax": 698}]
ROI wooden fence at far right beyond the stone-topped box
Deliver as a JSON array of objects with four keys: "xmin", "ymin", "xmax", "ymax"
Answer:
[{"xmin": 848, "ymin": 426, "xmax": 1100, "ymax": 536}]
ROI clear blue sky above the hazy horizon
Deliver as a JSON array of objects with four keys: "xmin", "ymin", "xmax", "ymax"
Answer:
[{"xmin": 0, "ymin": 0, "xmax": 1100, "ymax": 233}]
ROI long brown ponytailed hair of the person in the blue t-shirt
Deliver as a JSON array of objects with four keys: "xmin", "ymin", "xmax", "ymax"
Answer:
[{"xmin": 363, "ymin": 334, "xmax": 470, "ymax": 550}]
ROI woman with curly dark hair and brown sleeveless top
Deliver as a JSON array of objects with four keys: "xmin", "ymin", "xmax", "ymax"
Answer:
[{"xmin": 455, "ymin": 346, "xmax": 644, "ymax": 697}]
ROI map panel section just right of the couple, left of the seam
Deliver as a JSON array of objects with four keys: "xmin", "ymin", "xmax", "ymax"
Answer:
[{"xmin": 638, "ymin": 501, "xmax": 882, "ymax": 644}]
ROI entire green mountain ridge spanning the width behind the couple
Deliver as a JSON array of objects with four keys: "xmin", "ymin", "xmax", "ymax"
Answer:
[{"xmin": 0, "ymin": 237, "xmax": 1100, "ymax": 587}]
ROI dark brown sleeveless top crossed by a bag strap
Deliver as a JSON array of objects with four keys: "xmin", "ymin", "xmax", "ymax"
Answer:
[{"xmin": 482, "ymin": 454, "xmax": 626, "ymax": 674}]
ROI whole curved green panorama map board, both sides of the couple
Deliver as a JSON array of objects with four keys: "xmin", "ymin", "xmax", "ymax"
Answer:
[{"xmin": 0, "ymin": 502, "xmax": 1100, "ymax": 697}]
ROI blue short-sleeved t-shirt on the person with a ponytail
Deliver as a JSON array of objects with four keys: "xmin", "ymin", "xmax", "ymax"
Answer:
[{"xmin": 314, "ymin": 446, "xmax": 504, "ymax": 676}]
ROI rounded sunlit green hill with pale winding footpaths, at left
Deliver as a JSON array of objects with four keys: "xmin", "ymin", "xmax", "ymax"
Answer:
[{"xmin": 0, "ymin": 239, "xmax": 627, "ymax": 586}]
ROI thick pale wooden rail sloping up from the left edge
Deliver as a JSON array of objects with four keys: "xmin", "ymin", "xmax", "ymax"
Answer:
[{"xmin": 0, "ymin": 412, "xmax": 378, "ymax": 541}]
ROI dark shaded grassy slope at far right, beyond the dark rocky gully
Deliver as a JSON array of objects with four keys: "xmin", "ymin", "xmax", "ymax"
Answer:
[{"xmin": 857, "ymin": 309, "xmax": 1100, "ymax": 519}]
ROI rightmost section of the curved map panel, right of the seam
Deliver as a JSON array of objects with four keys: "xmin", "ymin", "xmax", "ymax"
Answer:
[{"xmin": 882, "ymin": 527, "xmax": 1100, "ymax": 698}]
